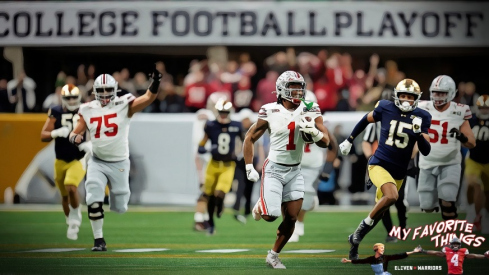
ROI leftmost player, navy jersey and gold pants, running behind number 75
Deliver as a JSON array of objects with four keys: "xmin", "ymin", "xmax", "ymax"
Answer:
[{"xmin": 41, "ymin": 84, "xmax": 91, "ymax": 240}]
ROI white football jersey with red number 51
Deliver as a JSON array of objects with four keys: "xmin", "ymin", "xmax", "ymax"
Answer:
[{"xmin": 418, "ymin": 101, "xmax": 472, "ymax": 169}]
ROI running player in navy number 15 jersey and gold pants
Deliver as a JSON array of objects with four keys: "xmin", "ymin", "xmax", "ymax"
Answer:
[{"xmin": 339, "ymin": 79, "xmax": 431, "ymax": 260}]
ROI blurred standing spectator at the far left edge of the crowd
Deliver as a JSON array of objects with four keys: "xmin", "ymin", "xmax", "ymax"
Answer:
[{"xmin": 7, "ymin": 70, "xmax": 36, "ymax": 113}]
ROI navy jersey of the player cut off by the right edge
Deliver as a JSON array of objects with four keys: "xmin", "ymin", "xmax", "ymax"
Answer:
[{"xmin": 469, "ymin": 116, "xmax": 489, "ymax": 164}]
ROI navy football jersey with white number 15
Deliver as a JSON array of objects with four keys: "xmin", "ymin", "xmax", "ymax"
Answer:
[{"xmin": 369, "ymin": 100, "xmax": 431, "ymax": 180}]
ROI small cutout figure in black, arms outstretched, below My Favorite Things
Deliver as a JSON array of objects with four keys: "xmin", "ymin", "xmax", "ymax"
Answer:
[{"xmin": 341, "ymin": 243, "xmax": 423, "ymax": 275}]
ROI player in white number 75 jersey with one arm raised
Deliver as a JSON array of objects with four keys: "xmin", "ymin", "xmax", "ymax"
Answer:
[{"xmin": 70, "ymin": 69, "xmax": 161, "ymax": 251}]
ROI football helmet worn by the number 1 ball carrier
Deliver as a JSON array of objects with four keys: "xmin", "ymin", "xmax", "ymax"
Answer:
[{"xmin": 275, "ymin": 71, "xmax": 306, "ymax": 105}]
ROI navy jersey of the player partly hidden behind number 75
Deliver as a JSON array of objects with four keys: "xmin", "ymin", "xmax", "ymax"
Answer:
[{"xmin": 48, "ymin": 106, "xmax": 85, "ymax": 162}]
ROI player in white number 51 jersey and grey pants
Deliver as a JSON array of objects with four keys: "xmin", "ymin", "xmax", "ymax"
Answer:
[{"xmin": 418, "ymin": 75, "xmax": 475, "ymax": 220}]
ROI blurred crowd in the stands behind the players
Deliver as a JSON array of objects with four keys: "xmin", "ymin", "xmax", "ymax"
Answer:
[{"xmin": 0, "ymin": 48, "xmax": 477, "ymax": 113}]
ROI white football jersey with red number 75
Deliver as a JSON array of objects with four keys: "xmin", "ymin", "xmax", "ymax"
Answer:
[{"xmin": 78, "ymin": 94, "xmax": 135, "ymax": 161}]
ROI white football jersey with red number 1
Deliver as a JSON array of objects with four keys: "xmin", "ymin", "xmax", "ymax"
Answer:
[{"xmin": 258, "ymin": 102, "xmax": 321, "ymax": 165}]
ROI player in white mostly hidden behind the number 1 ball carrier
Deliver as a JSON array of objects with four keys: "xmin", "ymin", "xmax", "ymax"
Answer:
[{"xmin": 289, "ymin": 90, "xmax": 338, "ymax": 242}]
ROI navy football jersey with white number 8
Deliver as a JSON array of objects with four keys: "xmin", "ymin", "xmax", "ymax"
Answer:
[{"xmin": 204, "ymin": 120, "xmax": 243, "ymax": 161}]
